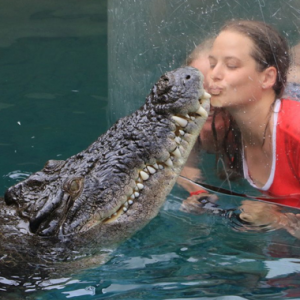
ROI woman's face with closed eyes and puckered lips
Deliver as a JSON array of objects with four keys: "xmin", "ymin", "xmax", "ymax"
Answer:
[{"xmin": 207, "ymin": 30, "xmax": 262, "ymax": 109}]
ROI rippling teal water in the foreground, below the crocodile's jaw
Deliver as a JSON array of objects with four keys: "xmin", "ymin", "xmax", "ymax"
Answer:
[{"xmin": 2, "ymin": 193, "xmax": 300, "ymax": 299}]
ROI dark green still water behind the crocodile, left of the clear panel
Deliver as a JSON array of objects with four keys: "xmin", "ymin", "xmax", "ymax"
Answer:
[{"xmin": 0, "ymin": 0, "xmax": 108, "ymax": 194}]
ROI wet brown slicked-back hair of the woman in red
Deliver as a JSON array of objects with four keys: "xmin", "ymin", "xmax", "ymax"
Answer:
[{"xmin": 221, "ymin": 20, "xmax": 290, "ymax": 98}]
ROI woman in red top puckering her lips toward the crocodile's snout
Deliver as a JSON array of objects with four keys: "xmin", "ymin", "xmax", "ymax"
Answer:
[{"xmin": 184, "ymin": 21, "xmax": 300, "ymax": 237}]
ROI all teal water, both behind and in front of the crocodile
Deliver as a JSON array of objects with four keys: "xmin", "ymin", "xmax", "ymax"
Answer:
[{"xmin": 0, "ymin": 0, "xmax": 300, "ymax": 300}]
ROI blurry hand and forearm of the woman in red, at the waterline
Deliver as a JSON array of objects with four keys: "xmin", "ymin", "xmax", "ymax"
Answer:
[{"xmin": 239, "ymin": 200, "xmax": 300, "ymax": 239}]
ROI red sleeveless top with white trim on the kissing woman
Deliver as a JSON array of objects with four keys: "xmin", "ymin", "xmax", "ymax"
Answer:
[{"xmin": 244, "ymin": 99, "xmax": 300, "ymax": 208}]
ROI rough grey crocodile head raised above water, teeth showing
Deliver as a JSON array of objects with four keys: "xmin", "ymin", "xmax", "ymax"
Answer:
[{"xmin": 5, "ymin": 67, "xmax": 209, "ymax": 243}]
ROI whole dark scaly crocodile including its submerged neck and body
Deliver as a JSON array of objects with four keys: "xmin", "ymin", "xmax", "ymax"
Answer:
[{"xmin": 0, "ymin": 67, "xmax": 209, "ymax": 286}]
